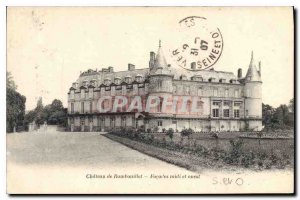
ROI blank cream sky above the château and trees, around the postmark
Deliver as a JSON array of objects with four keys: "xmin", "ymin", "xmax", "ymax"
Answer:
[{"xmin": 7, "ymin": 7, "xmax": 294, "ymax": 110}]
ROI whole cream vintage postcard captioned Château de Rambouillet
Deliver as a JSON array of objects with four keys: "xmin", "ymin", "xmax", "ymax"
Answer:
[{"xmin": 6, "ymin": 7, "xmax": 295, "ymax": 194}]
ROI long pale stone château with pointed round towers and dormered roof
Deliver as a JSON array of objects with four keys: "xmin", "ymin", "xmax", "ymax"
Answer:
[{"xmin": 68, "ymin": 41, "xmax": 262, "ymax": 132}]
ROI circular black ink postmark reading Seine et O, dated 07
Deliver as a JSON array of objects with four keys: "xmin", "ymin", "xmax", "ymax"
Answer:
[{"xmin": 171, "ymin": 16, "xmax": 224, "ymax": 71}]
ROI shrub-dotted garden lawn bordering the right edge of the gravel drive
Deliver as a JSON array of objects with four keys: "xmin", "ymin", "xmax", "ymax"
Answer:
[{"xmin": 106, "ymin": 130, "xmax": 294, "ymax": 170}]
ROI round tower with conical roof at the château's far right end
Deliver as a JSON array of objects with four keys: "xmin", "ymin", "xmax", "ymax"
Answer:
[{"xmin": 244, "ymin": 52, "xmax": 262, "ymax": 131}]
